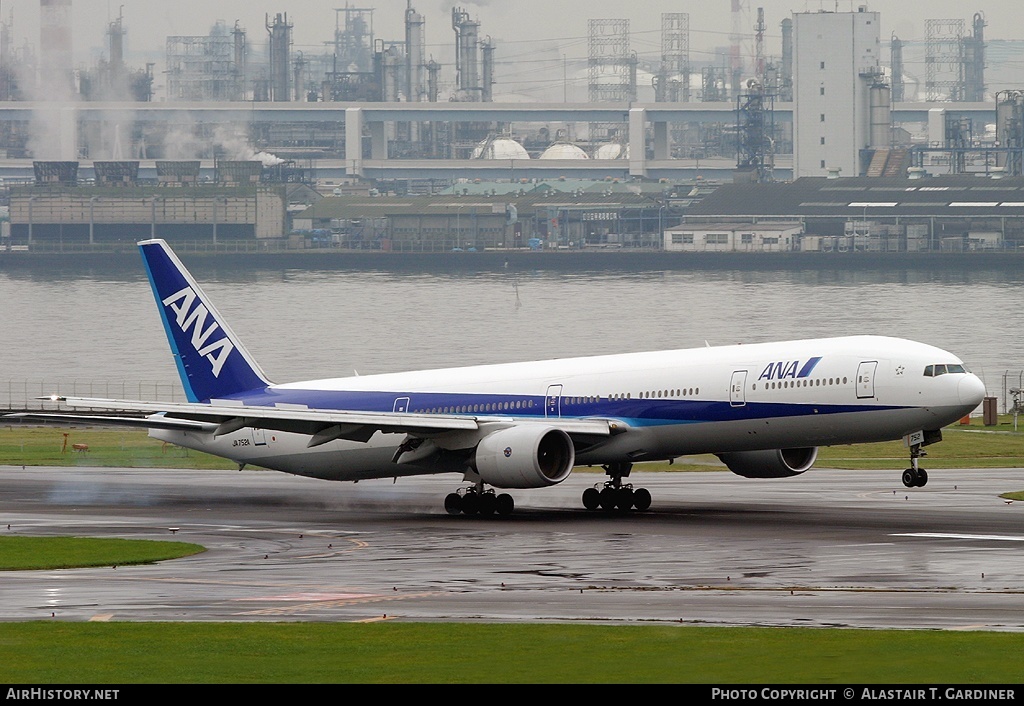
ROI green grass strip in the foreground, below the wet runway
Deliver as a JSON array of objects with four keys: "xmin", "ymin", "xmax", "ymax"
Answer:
[{"xmin": 0, "ymin": 622, "xmax": 1024, "ymax": 684}]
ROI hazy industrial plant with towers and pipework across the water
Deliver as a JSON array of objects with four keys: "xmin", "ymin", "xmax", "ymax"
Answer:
[{"xmin": 0, "ymin": 0, "xmax": 1024, "ymax": 252}]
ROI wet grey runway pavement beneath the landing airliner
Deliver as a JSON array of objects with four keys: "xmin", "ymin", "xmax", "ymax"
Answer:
[{"xmin": 0, "ymin": 466, "xmax": 1024, "ymax": 631}]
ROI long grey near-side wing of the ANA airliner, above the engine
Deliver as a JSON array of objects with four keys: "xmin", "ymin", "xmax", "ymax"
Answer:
[{"xmin": 9, "ymin": 397, "xmax": 625, "ymax": 446}]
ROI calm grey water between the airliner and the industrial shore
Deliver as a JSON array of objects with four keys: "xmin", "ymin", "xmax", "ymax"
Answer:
[{"xmin": 0, "ymin": 257, "xmax": 1024, "ymax": 399}]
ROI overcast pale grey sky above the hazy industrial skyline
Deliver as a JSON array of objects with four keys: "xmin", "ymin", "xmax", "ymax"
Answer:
[{"xmin": 0, "ymin": 0, "xmax": 1024, "ymax": 98}]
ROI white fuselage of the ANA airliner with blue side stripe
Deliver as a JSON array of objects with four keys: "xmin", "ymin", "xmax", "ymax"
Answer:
[{"xmin": 151, "ymin": 336, "xmax": 984, "ymax": 481}]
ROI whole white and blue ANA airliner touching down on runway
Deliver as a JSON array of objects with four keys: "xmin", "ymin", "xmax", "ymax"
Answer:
[{"xmin": 10, "ymin": 239, "xmax": 985, "ymax": 515}]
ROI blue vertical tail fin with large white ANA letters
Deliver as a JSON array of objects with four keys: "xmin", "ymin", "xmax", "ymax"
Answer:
[{"xmin": 138, "ymin": 240, "xmax": 270, "ymax": 402}]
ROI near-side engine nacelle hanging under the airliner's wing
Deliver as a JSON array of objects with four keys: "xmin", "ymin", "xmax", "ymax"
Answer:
[{"xmin": 473, "ymin": 424, "xmax": 575, "ymax": 488}]
